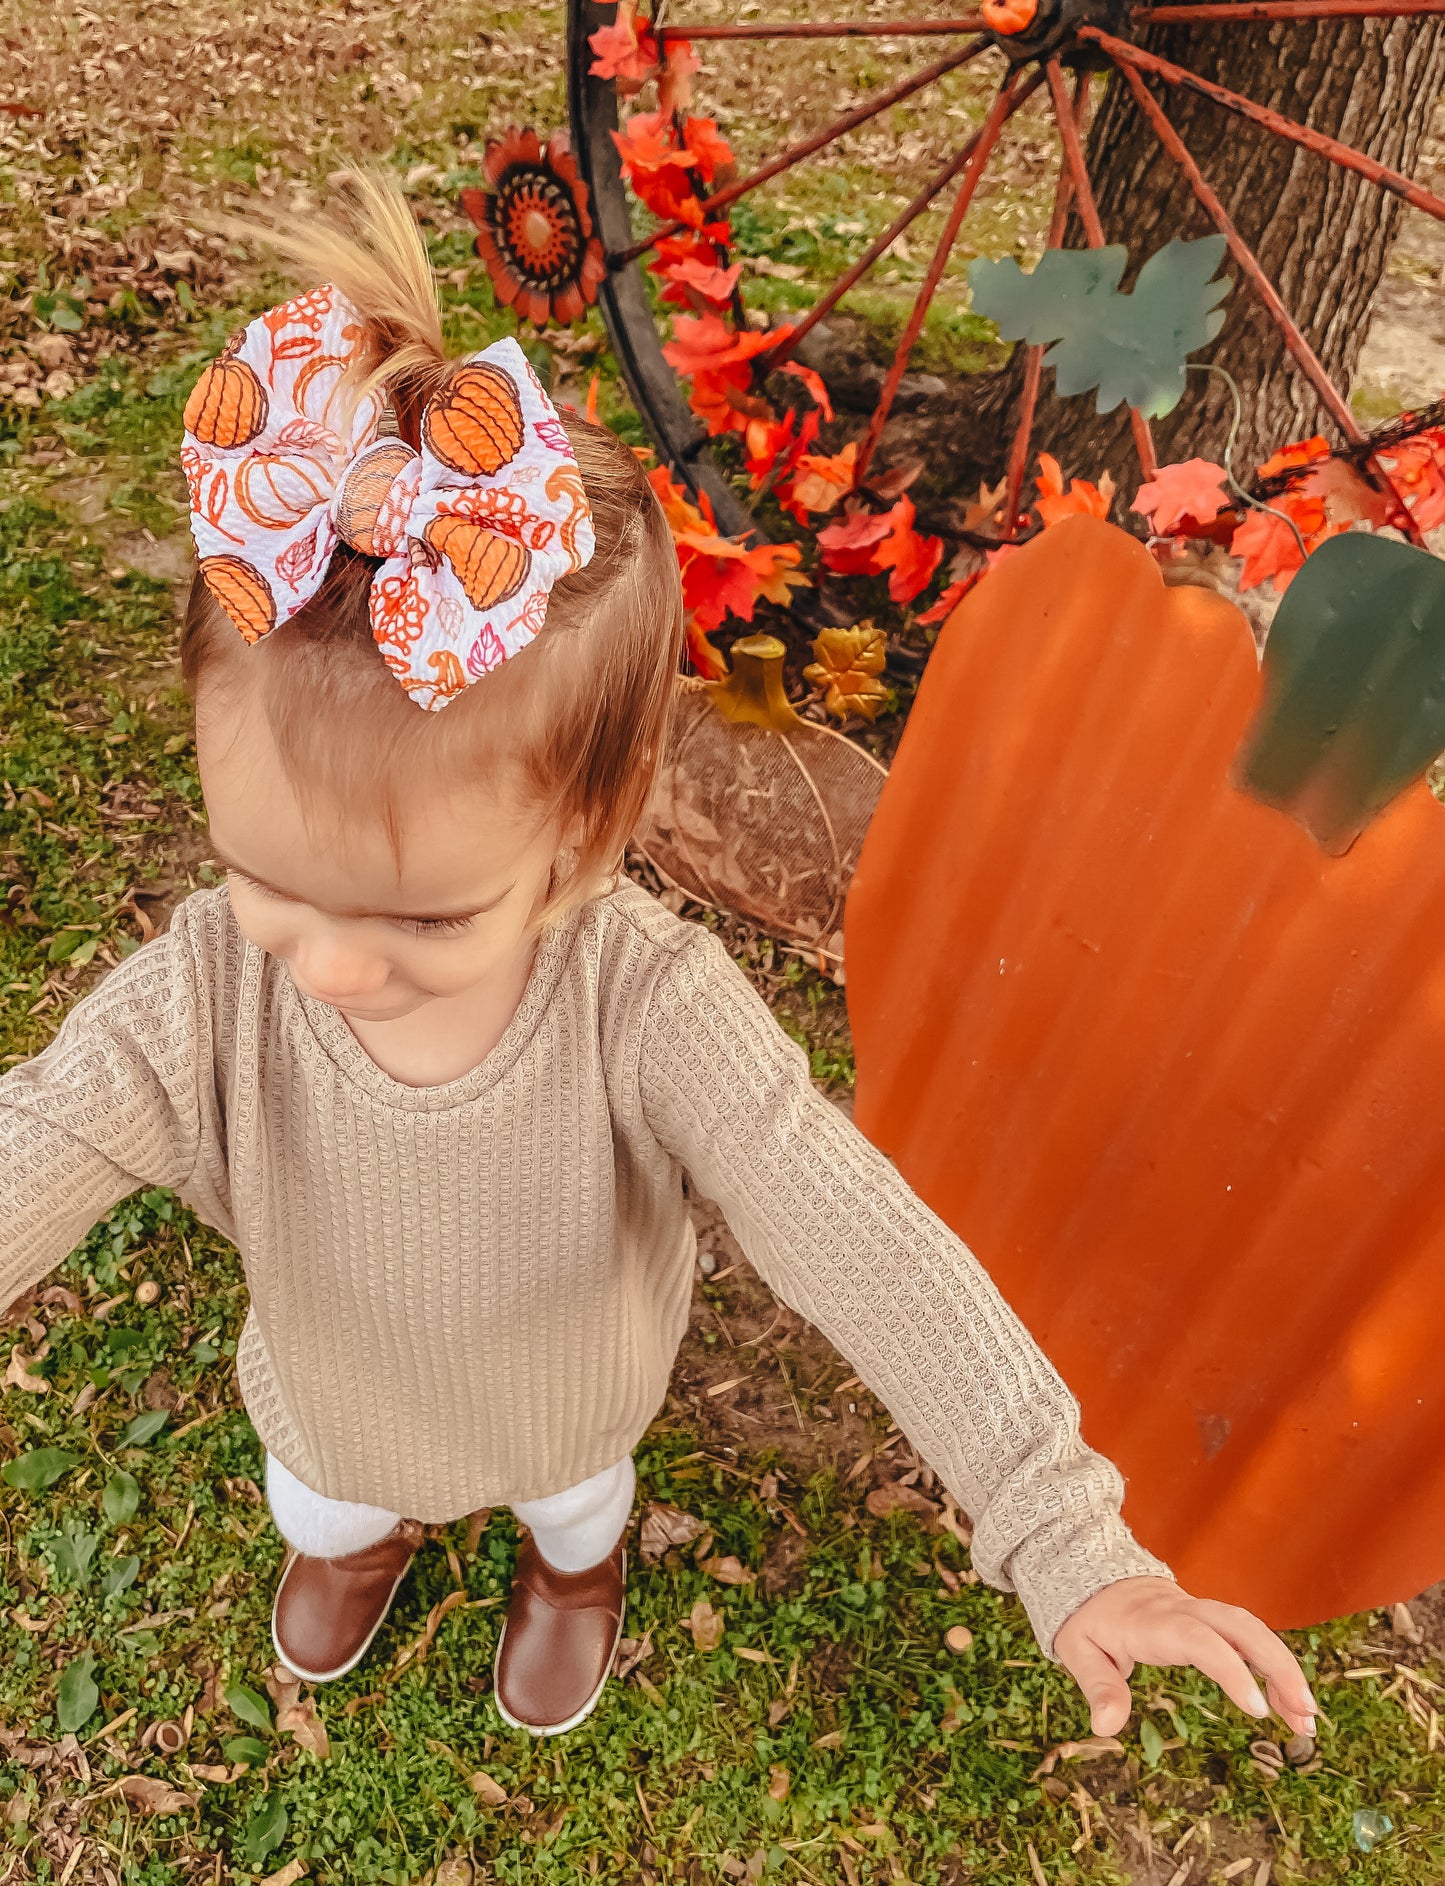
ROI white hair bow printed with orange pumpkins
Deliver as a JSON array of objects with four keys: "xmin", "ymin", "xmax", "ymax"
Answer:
[{"xmin": 181, "ymin": 287, "xmax": 594, "ymax": 709}]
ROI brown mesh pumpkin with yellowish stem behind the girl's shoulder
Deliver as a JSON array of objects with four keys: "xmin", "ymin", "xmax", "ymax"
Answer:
[{"xmin": 634, "ymin": 636, "xmax": 887, "ymax": 975}]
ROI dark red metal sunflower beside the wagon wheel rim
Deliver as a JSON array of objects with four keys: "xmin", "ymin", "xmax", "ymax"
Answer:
[{"xmin": 460, "ymin": 124, "xmax": 607, "ymax": 328}]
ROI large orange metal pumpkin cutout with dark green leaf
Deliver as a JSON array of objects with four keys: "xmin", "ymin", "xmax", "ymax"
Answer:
[{"xmin": 845, "ymin": 519, "xmax": 1445, "ymax": 1626}]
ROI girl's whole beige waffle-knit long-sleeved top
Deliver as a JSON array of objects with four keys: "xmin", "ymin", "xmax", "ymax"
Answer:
[{"xmin": 0, "ymin": 883, "xmax": 1164, "ymax": 1648}]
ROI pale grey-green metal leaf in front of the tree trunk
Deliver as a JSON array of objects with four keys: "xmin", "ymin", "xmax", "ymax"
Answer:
[{"xmin": 968, "ymin": 236, "xmax": 1232, "ymax": 419}]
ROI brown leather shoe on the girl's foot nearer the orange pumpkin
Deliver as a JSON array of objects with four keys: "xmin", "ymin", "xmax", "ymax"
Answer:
[{"xmin": 494, "ymin": 1537, "xmax": 626, "ymax": 1735}]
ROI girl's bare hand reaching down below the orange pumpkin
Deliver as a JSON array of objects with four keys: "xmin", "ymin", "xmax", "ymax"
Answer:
[{"xmin": 1055, "ymin": 1579, "xmax": 1319, "ymax": 1735}]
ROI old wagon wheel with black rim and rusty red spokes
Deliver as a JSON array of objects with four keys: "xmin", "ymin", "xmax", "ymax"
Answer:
[{"xmin": 550, "ymin": 0, "xmax": 1445, "ymax": 641}]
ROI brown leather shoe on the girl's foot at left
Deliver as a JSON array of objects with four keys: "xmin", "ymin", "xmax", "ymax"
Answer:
[{"xmin": 272, "ymin": 1520, "xmax": 423, "ymax": 1682}]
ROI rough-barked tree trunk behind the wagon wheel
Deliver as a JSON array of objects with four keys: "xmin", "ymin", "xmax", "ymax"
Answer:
[{"xmin": 979, "ymin": 19, "xmax": 1445, "ymax": 492}]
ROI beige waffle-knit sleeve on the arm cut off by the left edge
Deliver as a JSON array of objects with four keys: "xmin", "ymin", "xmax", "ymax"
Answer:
[{"xmin": 0, "ymin": 913, "xmax": 209, "ymax": 1309}]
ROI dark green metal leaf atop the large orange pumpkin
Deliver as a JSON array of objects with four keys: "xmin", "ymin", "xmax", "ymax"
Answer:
[{"xmin": 1236, "ymin": 532, "xmax": 1445, "ymax": 854}]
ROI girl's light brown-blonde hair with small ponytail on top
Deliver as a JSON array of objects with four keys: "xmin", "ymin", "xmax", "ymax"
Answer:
[{"xmin": 181, "ymin": 175, "xmax": 683, "ymax": 924}]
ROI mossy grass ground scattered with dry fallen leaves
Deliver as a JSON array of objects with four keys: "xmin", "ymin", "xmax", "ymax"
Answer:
[{"xmin": 0, "ymin": 0, "xmax": 1445, "ymax": 1886}]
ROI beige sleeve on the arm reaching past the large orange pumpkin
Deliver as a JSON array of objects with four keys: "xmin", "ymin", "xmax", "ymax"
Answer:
[{"xmin": 639, "ymin": 930, "xmax": 1168, "ymax": 1654}]
